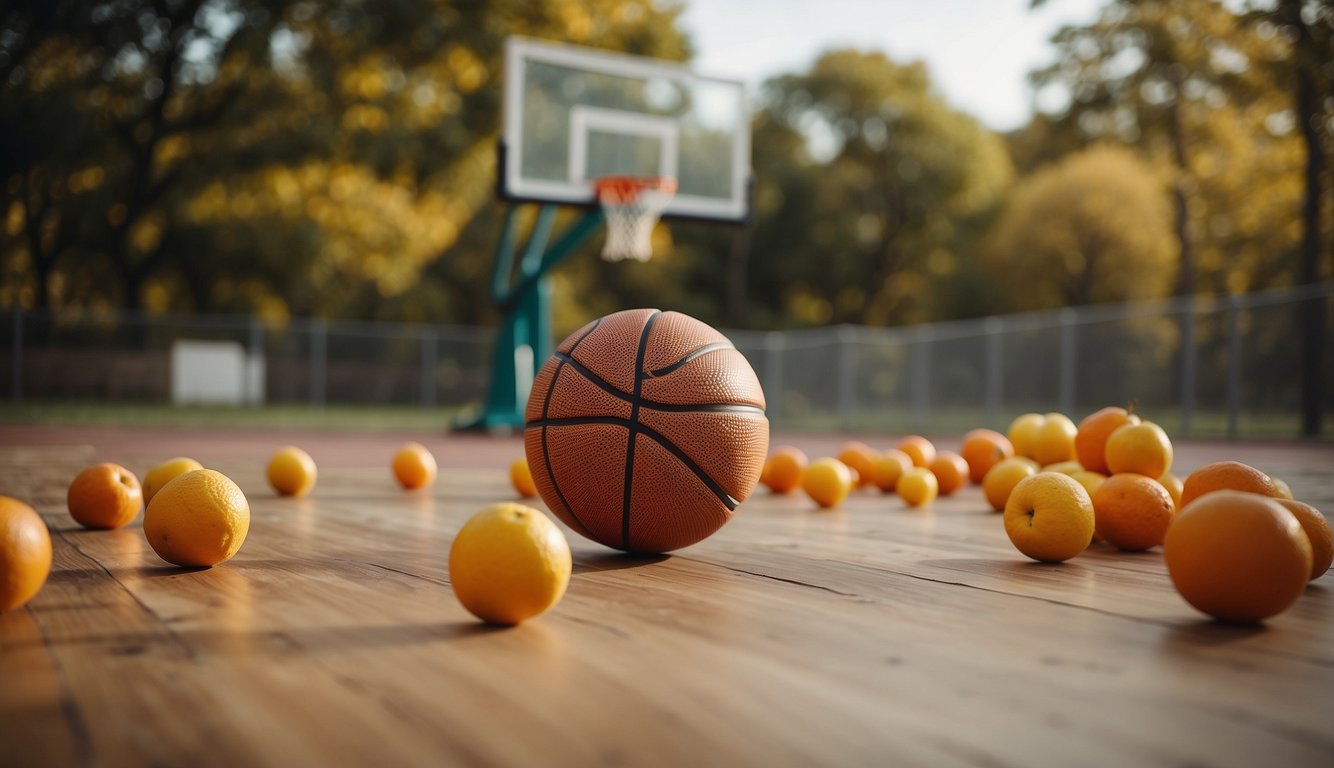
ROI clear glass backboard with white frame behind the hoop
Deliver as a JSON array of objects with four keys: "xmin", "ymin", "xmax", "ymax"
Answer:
[{"xmin": 500, "ymin": 37, "xmax": 750, "ymax": 221}]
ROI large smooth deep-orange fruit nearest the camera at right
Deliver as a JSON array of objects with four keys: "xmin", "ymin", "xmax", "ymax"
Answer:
[{"xmin": 1163, "ymin": 490, "xmax": 1311, "ymax": 621}]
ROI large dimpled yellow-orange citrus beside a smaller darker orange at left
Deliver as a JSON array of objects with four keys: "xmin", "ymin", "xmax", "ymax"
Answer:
[{"xmin": 144, "ymin": 469, "xmax": 249, "ymax": 568}]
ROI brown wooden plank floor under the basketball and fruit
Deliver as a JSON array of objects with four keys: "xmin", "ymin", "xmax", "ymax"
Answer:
[{"xmin": 0, "ymin": 427, "xmax": 1334, "ymax": 768}]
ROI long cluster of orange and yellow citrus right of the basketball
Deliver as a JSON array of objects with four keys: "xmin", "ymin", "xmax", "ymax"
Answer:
[{"xmin": 760, "ymin": 407, "xmax": 1334, "ymax": 621}]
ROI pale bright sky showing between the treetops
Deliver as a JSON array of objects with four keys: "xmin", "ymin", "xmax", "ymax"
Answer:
[{"xmin": 683, "ymin": 0, "xmax": 1105, "ymax": 131}]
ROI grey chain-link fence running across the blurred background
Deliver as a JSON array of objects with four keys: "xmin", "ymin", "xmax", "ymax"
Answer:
[{"xmin": 0, "ymin": 284, "xmax": 1334, "ymax": 437}]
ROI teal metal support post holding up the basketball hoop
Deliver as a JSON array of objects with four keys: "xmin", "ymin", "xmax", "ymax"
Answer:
[{"xmin": 459, "ymin": 205, "xmax": 603, "ymax": 431}]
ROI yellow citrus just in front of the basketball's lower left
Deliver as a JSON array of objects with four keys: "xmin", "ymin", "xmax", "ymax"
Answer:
[{"xmin": 450, "ymin": 503, "xmax": 574, "ymax": 625}]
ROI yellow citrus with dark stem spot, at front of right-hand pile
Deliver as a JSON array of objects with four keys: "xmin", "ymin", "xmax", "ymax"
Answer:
[{"xmin": 1005, "ymin": 472, "xmax": 1094, "ymax": 563}]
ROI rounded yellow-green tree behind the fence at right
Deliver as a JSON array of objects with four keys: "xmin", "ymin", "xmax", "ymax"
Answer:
[{"xmin": 984, "ymin": 145, "xmax": 1174, "ymax": 309}]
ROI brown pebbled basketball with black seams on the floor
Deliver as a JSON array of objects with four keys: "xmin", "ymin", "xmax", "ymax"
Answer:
[{"xmin": 523, "ymin": 309, "xmax": 768, "ymax": 553}]
